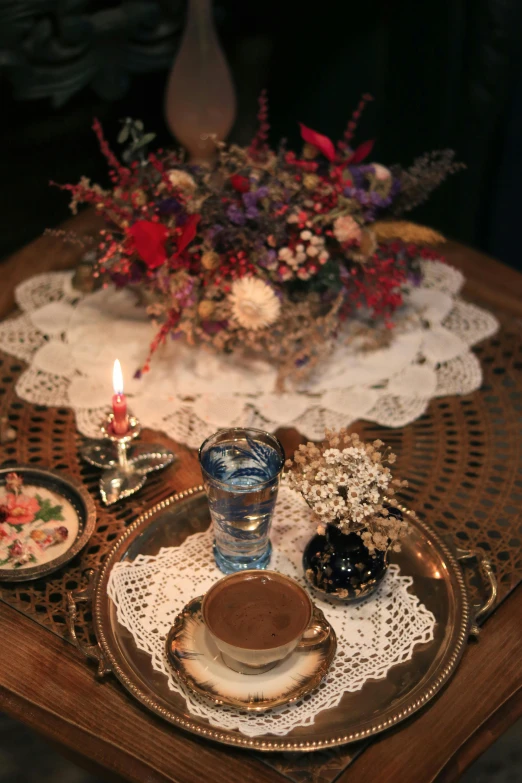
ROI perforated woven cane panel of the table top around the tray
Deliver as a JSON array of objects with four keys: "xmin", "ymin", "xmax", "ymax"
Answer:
[{"xmin": 0, "ymin": 319, "xmax": 522, "ymax": 783}]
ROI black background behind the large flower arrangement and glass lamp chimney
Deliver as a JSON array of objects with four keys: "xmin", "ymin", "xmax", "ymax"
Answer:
[{"xmin": 0, "ymin": 0, "xmax": 522, "ymax": 268}]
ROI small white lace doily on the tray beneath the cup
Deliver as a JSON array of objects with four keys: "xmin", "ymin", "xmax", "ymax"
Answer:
[{"xmin": 108, "ymin": 486, "xmax": 436, "ymax": 737}]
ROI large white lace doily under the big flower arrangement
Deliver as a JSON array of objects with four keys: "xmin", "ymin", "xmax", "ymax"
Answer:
[{"xmin": 0, "ymin": 261, "xmax": 498, "ymax": 448}]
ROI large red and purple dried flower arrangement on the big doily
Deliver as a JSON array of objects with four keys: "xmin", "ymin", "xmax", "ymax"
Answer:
[{"xmin": 51, "ymin": 94, "xmax": 459, "ymax": 385}]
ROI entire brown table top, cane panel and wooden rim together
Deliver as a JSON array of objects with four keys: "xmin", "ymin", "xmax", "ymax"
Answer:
[{"xmin": 0, "ymin": 210, "xmax": 522, "ymax": 783}]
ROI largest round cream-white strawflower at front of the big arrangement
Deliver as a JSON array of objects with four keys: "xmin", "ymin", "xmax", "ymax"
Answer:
[{"xmin": 229, "ymin": 277, "xmax": 281, "ymax": 330}]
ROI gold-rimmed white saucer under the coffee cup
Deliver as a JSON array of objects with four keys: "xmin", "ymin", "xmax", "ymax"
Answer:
[{"xmin": 166, "ymin": 596, "xmax": 337, "ymax": 712}]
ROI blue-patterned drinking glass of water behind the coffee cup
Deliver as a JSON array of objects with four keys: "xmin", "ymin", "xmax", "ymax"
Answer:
[{"xmin": 199, "ymin": 427, "xmax": 285, "ymax": 574}]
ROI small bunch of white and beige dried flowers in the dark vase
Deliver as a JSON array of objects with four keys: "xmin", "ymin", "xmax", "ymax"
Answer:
[{"xmin": 286, "ymin": 429, "xmax": 408, "ymax": 553}]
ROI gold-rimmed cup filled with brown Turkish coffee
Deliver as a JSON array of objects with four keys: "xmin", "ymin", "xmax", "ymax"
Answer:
[{"xmin": 201, "ymin": 570, "xmax": 331, "ymax": 674}]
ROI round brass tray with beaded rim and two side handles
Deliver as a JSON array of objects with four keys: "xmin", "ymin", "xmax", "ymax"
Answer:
[{"xmin": 68, "ymin": 487, "xmax": 495, "ymax": 751}]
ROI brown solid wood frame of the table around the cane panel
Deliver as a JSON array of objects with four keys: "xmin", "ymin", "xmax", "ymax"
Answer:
[{"xmin": 0, "ymin": 213, "xmax": 522, "ymax": 783}]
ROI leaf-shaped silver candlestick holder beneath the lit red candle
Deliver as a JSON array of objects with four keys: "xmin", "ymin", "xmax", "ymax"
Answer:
[{"xmin": 80, "ymin": 413, "xmax": 176, "ymax": 506}]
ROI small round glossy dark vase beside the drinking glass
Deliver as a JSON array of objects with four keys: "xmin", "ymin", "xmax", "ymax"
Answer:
[{"xmin": 303, "ymin": 525, "xmax": 388, "ymax": 603}]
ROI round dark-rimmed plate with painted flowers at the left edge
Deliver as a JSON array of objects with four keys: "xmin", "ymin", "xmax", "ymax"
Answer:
[{"xmin": 0, "ymin": 465, "xmax": 96, "ymax": 582}]
